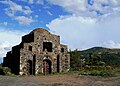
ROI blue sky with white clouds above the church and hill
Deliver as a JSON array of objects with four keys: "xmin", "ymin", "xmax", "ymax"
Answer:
[{"xmin": 0, "ymin": 0, "xmax": 120, "ymax": 62}]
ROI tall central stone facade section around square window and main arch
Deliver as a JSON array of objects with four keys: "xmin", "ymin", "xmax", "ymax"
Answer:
[{"xmin": 34, "ymin": 31, "xmax": 60, "ymax": 73}]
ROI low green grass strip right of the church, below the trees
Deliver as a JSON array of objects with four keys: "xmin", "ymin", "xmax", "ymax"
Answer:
[{"xmin": 70, "ymin": 66, "xmax": 117, "ymax": 77}]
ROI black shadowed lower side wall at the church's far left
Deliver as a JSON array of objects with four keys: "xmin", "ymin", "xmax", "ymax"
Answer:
[{"xmin": 3, "ymin": 45, "xmax": 21, "ymax": 75}]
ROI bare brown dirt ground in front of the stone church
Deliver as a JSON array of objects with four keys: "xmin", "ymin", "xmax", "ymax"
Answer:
[{"xmin": 0, "ymin": 74, "xmax": 120, "ymax": 86}]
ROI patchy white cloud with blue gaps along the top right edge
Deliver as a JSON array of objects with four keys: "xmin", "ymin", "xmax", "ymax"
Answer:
[{"xmin": 47, "ymin": 0, "xmax": 120, "ymax": 17}]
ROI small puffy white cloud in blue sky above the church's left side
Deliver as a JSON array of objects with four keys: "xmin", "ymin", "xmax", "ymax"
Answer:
[{"xmin": 15, "ymin": 16, "xmax": 34, "ymax": 25}]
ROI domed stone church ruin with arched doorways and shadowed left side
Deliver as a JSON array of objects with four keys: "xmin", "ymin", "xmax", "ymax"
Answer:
[{"xmin": 3, "ymin": 28, "xmax": 70, "ymax": 75}]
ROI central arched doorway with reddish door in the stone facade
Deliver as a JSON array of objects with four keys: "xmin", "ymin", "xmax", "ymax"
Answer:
[{"xmin": 43, "ymin": 59, "xmax": 52, "ymax": 75}]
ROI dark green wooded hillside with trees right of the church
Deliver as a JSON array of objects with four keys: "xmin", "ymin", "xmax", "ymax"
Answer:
[{"xmin": 70, "ymin": 47, "xmax": 120, "ymax": 76}]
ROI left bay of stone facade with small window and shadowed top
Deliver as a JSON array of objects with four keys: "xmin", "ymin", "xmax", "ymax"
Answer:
[{"xmin": 19, "ymin": 33, "xmax": 35, "ymax": 75}]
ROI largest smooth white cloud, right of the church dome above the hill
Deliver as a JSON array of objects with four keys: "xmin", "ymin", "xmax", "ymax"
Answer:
[{"xmin": 47, "ymin": 15, "xmax": 120, "ymax": 49}]
